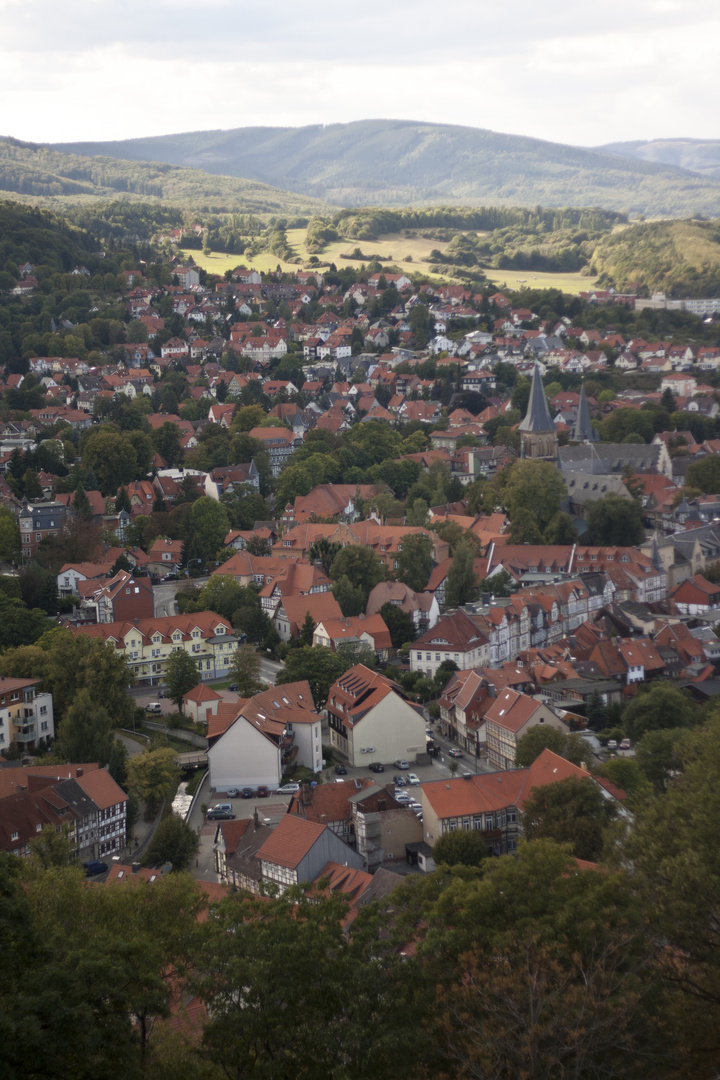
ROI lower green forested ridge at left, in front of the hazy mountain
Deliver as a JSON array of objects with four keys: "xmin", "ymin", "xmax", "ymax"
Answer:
[{"xmin": 0, "ymin": 138, "xmax": 326, "ymax": 216}]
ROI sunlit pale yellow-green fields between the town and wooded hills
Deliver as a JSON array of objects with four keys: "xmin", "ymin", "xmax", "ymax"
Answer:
[{"xmin": 181, "ymin": 229, "xmax": 595, "ymax": 295}]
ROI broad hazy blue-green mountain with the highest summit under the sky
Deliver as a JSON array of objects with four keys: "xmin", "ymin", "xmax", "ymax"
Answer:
[{"xmin": 50, "ymin": 120, "xmax": 720, "ymax": 217}]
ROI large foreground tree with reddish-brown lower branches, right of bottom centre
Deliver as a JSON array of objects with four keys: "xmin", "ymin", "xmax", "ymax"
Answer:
[{"xmin": 423, "ymin": 842, "xmax": 664, "ymax": 1080}]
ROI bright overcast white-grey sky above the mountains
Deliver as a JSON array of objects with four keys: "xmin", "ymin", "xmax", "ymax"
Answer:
[{"xmin": 0, "ymin": 0, "xmax": 720, "ymax": 146}]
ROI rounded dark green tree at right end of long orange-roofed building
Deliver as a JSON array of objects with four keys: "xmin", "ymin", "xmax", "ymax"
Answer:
[{"xmin": 522, "ymin": 777, "xmax": 616, "ymax": 862}]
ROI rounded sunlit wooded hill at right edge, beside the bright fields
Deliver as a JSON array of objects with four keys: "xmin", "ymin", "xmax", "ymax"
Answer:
[{"xmin": 592, "ymin": 221, "xmax": 720, "ymax": 297}]
